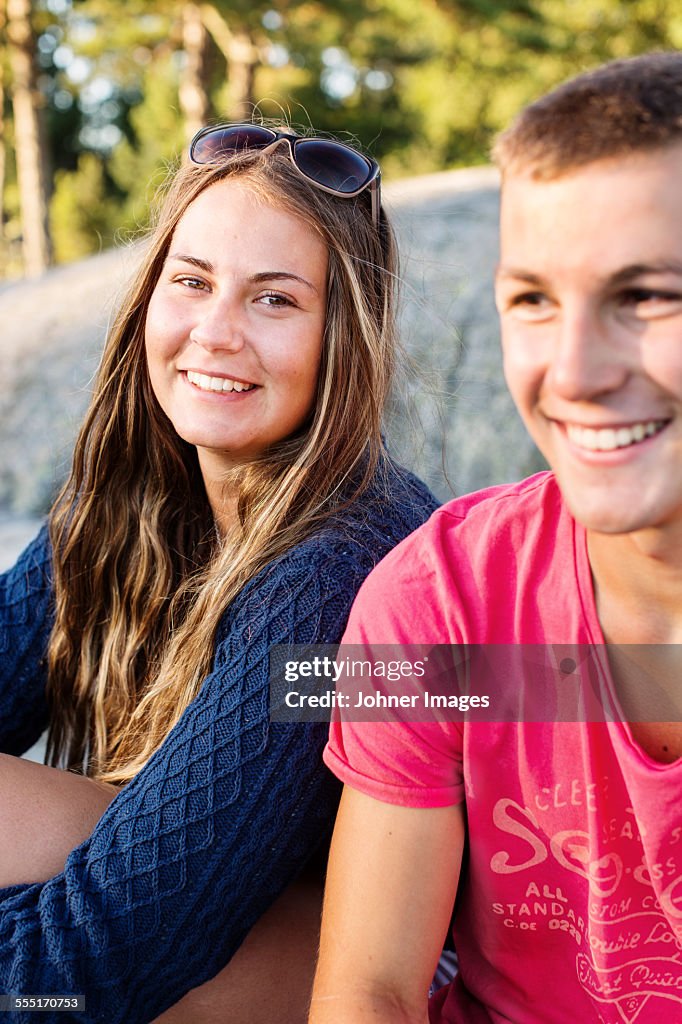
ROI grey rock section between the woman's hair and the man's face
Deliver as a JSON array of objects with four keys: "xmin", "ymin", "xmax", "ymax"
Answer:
[{"xmin": 386, "ymin": 168, "xmax": 545, "ymax": 501}]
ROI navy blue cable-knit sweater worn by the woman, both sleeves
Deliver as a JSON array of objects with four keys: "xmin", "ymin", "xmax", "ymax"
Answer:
[{"xmin": 0, "ymin": 467, "xmax": 436, "ymax": 1024}]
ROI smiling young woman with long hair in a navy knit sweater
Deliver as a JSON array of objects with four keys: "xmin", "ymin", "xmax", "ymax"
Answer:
[{"xmin": 0, "ymin": 125, "xmax": 434, "ymax": 1024}]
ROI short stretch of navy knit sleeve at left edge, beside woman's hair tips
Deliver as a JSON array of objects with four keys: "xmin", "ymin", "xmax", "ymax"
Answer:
[{"xmin": 0, "ymin": 527, "xmax": 52, "ymax": 754}]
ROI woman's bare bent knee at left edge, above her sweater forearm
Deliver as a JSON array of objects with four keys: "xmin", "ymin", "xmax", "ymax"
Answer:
[{"xmin": 0, "ymin": 754, "xmax": 118, "ymax": 888}]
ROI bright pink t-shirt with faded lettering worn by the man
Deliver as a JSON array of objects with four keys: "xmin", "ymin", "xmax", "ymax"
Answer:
[{"xmin": 325, "ymin": 473, "xmax": 682, "ymax": 1024}]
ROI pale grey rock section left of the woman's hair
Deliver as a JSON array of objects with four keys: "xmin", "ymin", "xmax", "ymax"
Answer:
[{"xmin": 0, "ymin": 250, "xmax": 135, "ymax": 517}]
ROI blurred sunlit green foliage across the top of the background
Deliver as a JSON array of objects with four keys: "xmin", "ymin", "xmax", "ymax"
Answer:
[{"xmin": 4, "ymin": 0, "xmax": 682, "ymax": 270}]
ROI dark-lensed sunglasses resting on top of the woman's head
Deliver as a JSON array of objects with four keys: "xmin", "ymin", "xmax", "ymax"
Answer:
[{"xmin": 189, "ymin": 124, "xmax": 381, "ymax": 227}]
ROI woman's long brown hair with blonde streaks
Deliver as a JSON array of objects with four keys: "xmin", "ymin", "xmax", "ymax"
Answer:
[{"xmin": 48, "ymin": 147, "xmax": 397, "ymax": 783}]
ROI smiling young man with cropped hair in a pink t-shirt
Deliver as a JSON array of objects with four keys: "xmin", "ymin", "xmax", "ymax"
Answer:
[{"xmin": 311, "ymin": 53, "xmax": 682, "ymax": 1024}]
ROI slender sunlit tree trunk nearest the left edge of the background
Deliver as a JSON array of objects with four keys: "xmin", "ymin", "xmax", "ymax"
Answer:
[{"xmin": 6, "ymin": 0, "xmax": 50, "ymax": 276}]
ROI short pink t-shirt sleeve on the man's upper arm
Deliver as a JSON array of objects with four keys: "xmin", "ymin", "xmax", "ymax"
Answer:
[{"xmin": 325, "ymin": 535, "xmax": 465, "ymax": 807}]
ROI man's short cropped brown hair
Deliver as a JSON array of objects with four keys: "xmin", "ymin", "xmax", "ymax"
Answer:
[{"xmin": 493, "ymin": 51, "xmax": 682, "ymax": 179}]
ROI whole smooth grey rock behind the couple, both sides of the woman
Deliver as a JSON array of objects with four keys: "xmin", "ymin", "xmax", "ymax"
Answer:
[{"xmin": 0, "ymin": 168, "xmax": 542, "ymax": 528}]
